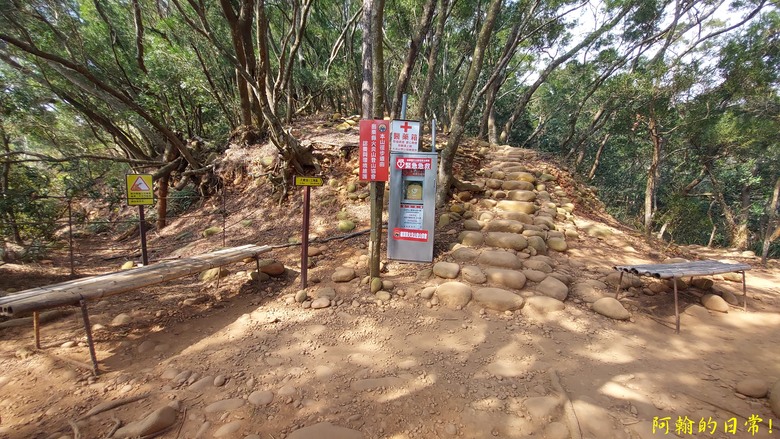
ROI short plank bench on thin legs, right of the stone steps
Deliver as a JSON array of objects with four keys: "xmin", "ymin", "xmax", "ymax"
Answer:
[{"xmin": 613, "ymin": 261, "xmax": 752, "ymax": 334}]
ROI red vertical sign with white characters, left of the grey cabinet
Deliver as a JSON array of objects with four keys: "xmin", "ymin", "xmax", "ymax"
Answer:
[{"xmin": 360, "ymin": 119, "xmax": 390, "ymax": 181}]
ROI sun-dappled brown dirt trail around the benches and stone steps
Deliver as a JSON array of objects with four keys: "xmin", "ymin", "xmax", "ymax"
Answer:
[{"xmin": 0, "ymin": 144, "xmax": 780, "ymax": 439}]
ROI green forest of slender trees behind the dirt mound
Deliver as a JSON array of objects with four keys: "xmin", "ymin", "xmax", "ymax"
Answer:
[{"xmin": 0, "ymin": 0, "xmax": 780, "ymax": 258}]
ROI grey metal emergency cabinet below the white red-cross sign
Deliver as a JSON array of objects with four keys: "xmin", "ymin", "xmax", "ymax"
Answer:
[{"xmin": 387, "ymin": 152, "xmax": 438, "ymax": 262}]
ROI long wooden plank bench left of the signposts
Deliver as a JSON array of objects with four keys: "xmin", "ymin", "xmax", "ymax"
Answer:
[{"xmin": 0, "ymin": 245, "xmax": 272, "ymax": 375}]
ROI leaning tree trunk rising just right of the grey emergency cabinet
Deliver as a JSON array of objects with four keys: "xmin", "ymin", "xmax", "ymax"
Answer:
[{"xmin": 436, "ymin": 0, "xmax": 503, "ymax": 206}]
